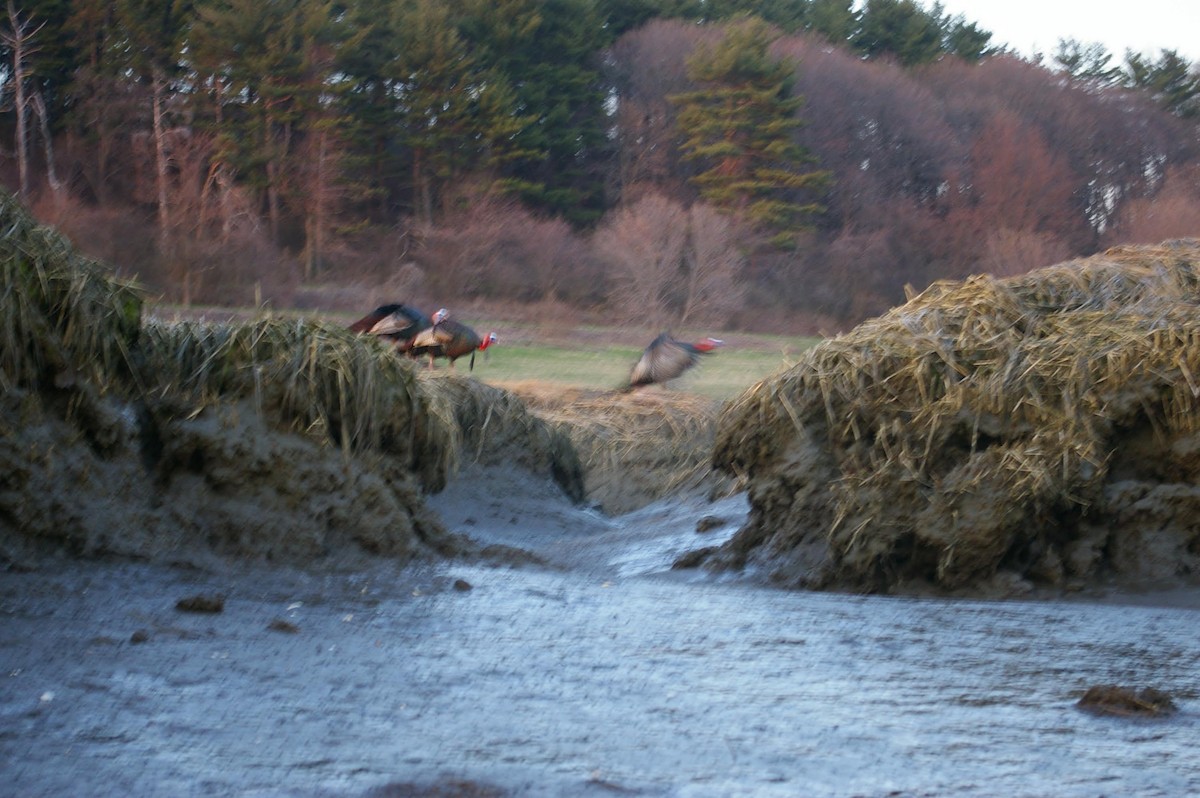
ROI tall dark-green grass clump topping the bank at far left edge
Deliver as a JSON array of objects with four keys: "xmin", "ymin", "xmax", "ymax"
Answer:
[{"xmin": 0, "ymin": 192, "xmax": 142, "ymax": 390}]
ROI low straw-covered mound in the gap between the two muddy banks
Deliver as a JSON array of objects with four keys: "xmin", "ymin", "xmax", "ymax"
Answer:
[{"xmin": 511, "ymin": 383, "xmax": 720, "ymax": 514}]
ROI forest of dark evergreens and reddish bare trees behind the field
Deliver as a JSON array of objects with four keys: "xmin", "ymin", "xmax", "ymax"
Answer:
[{"xmin": 0, "ymin": 0, "xmax": 1200, "ymax": 334}]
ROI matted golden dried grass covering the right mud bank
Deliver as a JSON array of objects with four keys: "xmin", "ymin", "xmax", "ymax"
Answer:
[{"xmin": 715, "ymin": 240, "xmax": 1200, "ymax": 589}]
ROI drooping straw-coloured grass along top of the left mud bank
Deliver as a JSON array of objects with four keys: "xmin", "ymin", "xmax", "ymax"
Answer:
[{"xmin": 0, "ymin": 188, "xmax": 561, "ymax": 504}]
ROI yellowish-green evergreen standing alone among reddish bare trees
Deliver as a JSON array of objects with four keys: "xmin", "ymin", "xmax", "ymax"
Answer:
[{"xmin": 672, "ymin": 19, "xmax": 828, "ymax": 244}]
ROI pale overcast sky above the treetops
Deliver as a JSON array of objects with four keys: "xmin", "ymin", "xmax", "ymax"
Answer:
[{"xmin": 922, "ymin": 0, "xmax": 1200, "ymax": 61}]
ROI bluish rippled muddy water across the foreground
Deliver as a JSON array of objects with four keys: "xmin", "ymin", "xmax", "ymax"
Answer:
[{"xmin": 0, "ymin": 492, "xmax": 1200, "ymax": 797}]
